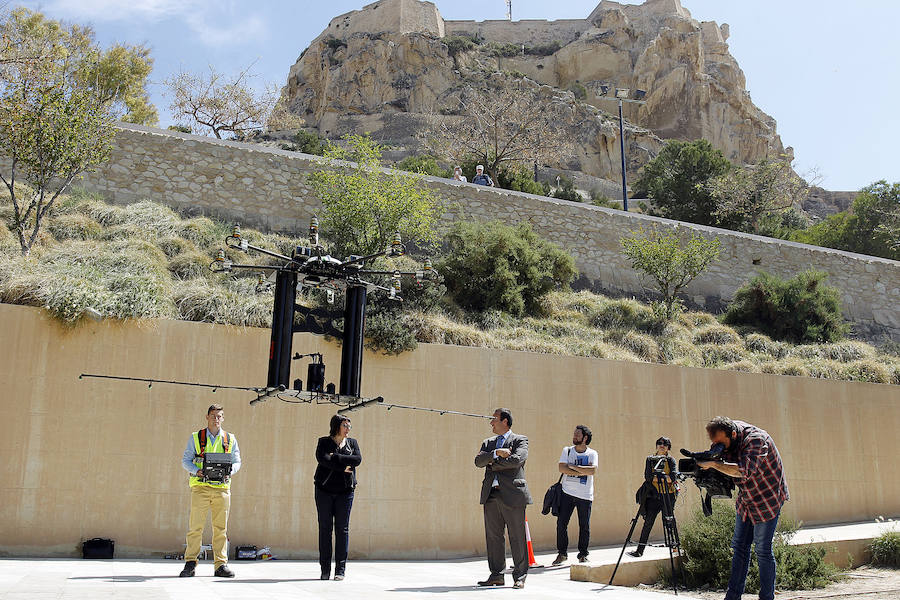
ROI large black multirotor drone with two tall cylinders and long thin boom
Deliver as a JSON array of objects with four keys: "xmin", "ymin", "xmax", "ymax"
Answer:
[{"xmin": 79, "ymin": 217, "xmax": 490, "ymax": 418}]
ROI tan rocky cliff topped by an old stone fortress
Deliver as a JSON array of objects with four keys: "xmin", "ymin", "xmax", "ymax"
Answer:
[{"xmin": 286, "ymin": 0, "xmax": 791, "ymax": 179}]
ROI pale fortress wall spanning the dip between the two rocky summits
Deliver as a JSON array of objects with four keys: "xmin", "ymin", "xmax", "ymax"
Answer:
[{"xmin": 444, "ymin": 19, "xmax": 591, "ymax": 46}]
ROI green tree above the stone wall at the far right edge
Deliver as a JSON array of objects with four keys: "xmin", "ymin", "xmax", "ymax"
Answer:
[{"xmin": 791, "ymin": 180, "xmax": 900, "ymax": 260}]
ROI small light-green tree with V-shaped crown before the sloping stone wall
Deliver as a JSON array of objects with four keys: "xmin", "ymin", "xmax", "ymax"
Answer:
[{"xmin": 622, "ymin": 227, "xmax": 721, "ymax": 319}]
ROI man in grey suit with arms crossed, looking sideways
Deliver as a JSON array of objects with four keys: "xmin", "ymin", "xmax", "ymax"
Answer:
[{"xmin": 475, "ymin": 408, "xmax": 531, "ymax": 589}]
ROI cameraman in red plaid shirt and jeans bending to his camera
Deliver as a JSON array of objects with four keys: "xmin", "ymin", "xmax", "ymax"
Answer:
[{"xmin": 697, "ymin": 417, "xmax": 790, "ymax": 600}]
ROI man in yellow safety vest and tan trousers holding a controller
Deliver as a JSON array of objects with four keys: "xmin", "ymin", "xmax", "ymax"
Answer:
[{"xmin": 180, "ymin": 404, "xmax": 241, "ymax": 577}]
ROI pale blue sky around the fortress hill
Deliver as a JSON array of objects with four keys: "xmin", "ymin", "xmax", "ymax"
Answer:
[{"xmin": 19, "ymin": 0, "xmax": 900, "ymax": 190}]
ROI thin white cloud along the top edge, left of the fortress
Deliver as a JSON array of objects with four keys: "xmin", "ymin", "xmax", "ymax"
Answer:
[{"xmin": 38, "ymin": 0, "xmax": 266, "ymax": 46}]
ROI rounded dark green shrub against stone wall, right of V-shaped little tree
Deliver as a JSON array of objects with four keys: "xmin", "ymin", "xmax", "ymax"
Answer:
[{"xmin": 722, "ymin": 270, "xmax": 849, "ymax": 343}]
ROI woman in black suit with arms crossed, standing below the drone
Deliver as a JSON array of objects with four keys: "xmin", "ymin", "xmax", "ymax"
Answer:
[{"xmin": 313, "ymin": 415, "xmax": 362, "ymax": 581}]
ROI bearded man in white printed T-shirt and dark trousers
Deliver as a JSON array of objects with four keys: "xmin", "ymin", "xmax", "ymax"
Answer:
[{"xmin": 553, "ymin": 425, "xmax": 597, "ymax": 565}]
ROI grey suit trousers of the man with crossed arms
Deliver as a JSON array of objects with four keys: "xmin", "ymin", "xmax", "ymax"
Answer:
[{"xmin": 484, "ymin": 491, "xmax": 528, "ymax": 581}]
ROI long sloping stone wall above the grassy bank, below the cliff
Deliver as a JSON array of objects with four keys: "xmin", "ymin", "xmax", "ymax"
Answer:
[{"xmin": 83, "ymin": 125, "xmax": 900, "ymax": 339}]
